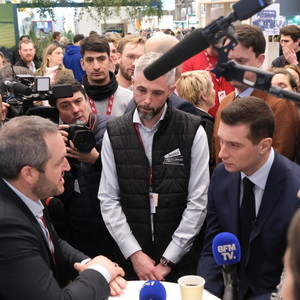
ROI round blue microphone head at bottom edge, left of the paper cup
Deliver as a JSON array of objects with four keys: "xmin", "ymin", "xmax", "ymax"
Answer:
[{"xmin": 139, "ymin": 280, "xmax": 167, "ymax": 300}]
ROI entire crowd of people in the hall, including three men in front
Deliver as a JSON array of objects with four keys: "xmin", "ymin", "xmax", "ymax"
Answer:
[{"xmin": 0, "ymin": 24, "xmax": 300, "ymax": 300}]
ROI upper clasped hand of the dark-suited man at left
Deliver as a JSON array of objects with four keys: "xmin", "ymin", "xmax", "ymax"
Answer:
[{"xmin": 74, "ymin": 255, "xmax": 125, "ymax": 282}]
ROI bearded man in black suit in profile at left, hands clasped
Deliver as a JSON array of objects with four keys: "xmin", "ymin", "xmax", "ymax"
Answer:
[{"xmin": 0, "ymin": 116, "xmax": 125, "ymax": 300}]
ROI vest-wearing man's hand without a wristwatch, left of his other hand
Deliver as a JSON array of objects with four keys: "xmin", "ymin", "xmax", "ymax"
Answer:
[{"xmin": 130, "ymin": 250, "xmax": 158, "ymax": 280}]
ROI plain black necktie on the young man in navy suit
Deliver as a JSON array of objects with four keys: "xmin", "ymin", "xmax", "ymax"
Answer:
[{"xmin": 240, "ymin": 177, "xmax": 256, "ymax": 265}]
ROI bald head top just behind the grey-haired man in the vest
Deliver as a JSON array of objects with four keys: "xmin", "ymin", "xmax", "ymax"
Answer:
[{"xmin": 145, "ymin": 32, "xmax": 179, "ymax": 53}]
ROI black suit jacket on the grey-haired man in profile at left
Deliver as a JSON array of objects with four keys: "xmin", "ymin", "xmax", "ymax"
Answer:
[{"xmin": 0, "ymin": 179, "xmax": 109, "ymax": 300}]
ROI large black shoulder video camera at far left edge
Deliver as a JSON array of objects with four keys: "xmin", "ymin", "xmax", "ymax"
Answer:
[{"xmin": 0, "ymin": 75, "xmax": 73, "ymax": 123}]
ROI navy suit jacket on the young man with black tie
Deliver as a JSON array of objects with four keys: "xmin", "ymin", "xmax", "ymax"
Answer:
[{"xmin": 197, "ymin": 153, "xmax": 300, "ymax": 300}]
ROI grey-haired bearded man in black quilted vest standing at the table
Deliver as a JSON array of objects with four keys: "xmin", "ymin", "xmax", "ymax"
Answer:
[{"xmin": 98, "ymin": 52, "xmax": 209, "ymax": 281}]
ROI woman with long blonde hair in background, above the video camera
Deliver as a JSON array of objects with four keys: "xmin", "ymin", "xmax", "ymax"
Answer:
[{"xmin": 35, "ymin": 43, "xmax": 74, "ymax": 84}]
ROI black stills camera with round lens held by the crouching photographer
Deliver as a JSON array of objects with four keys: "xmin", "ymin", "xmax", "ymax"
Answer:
[{"xmin": 65, "ymin": 124, "xmax": 96, "ymax": 153}]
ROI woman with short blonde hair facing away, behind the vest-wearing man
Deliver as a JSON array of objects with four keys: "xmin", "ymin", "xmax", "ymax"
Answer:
[{"xmin": 176, "ymin": 70, "xmax": 215, "ymax": 171}]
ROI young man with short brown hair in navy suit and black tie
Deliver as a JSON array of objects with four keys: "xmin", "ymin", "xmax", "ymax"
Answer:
[{"xmin": 197, "ymin": 97, "xmax": 300, "ymax": 300}]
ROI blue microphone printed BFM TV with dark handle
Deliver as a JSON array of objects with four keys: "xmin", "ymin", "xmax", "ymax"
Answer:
[{"xmin": 212, "ymin": 232, "xmax": 241, "ymax": 300}]
